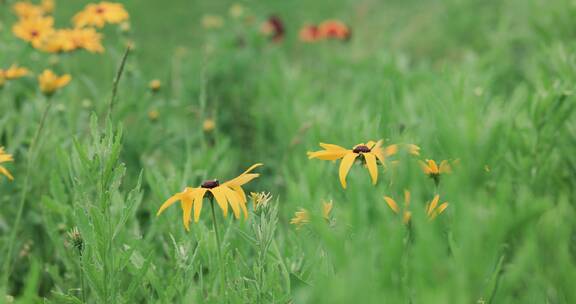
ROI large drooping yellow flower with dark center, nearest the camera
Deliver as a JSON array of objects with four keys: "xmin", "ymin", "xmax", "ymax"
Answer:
[{"xmin": 156, "ymin": 164, "xmax": 262, "ymax": 230}]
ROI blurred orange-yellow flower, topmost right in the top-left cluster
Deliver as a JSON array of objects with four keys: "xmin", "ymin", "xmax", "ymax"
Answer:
[{"xmin": 72, "ymin": 2, "xmax": 130, "ymax": 27}]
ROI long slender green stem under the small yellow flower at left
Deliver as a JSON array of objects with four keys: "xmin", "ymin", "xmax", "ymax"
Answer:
[{"xmin": 0, "ymin": 97, "xmax": 52, "ymax": 286}]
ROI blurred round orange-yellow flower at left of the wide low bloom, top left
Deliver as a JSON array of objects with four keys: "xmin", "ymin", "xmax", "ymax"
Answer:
[{"xmin": 12, "ymin": 17, "xmax": 54, "ymax": 48}]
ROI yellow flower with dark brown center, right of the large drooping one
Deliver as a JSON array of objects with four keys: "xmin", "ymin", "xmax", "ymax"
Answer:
[{"xmin": 308, "ymin": 140, "xmax": 398, "ymax": 189}]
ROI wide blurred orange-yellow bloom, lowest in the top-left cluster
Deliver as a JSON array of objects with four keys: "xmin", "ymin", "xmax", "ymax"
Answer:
[{"xmin": 41, "ymin": 28, "xmax": 104, "ymax": 53}]
